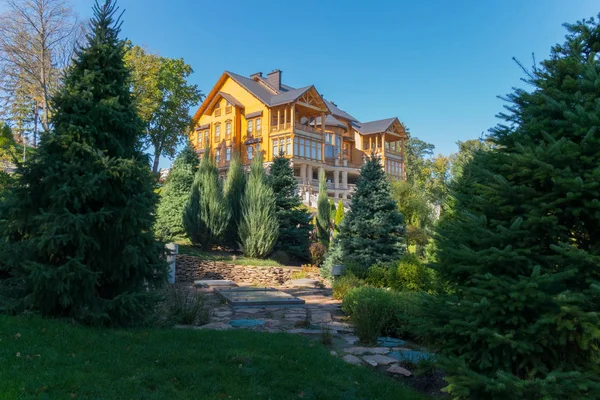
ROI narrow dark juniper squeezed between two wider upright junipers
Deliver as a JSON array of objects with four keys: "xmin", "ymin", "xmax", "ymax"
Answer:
[{"xmin": 224, "ymin": 154, "xmax": 246, "ymax": 247}]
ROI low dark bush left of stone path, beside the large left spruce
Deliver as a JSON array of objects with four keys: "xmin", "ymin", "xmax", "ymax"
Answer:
[{"xmin": 167, "ymin": 286, "xmax": 210, "ymax": 325}]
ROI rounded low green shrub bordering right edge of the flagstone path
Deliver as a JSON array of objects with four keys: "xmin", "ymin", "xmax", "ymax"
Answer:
[{"xmin": 342, "ymin": 286, "xmax": 394, "ymax": 344}]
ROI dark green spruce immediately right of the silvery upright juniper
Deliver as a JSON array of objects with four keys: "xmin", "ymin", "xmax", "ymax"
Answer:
[{"xmin": 268, "ymin": 156, "xmax": 311, "ymax": 259}]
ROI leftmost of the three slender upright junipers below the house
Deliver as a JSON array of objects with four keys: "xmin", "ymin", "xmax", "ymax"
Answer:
[{"xmin": 183, "ymin": 149, "xmax": 231, "ymax": 250}]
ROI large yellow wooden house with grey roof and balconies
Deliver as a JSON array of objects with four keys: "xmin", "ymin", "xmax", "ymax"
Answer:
[{"xmin": 190, "ymin": 70, "xmax": 408, "ymax": 206}]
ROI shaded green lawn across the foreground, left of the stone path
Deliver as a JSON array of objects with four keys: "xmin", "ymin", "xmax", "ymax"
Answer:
[{"xmin": 0, "ymin": 315, "xmax": 427, "ymax": 400}]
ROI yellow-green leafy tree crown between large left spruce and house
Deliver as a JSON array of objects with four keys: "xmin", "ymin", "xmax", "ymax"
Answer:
[{"xmin": 125, "ymin": 44, "xmax": 203, "ymax": 173}]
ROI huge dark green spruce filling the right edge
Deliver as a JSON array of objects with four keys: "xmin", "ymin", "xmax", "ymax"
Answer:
[{"xmin": 422, "ymin": 15, "xmax": 600, "ymax": 400}]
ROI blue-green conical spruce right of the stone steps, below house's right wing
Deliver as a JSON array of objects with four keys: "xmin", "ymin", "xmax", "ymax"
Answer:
[{"xmin": 337, "ymin": 156, "xmax": 405, "ymax": 270}]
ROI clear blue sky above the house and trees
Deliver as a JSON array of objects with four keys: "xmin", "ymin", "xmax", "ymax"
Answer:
[{"xmin": 74, "ymin": 0, "xmax": 600, "ymax": 167}]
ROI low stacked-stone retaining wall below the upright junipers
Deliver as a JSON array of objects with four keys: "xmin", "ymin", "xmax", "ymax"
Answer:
[{"xmin": 175, "ymin": 255, "xmax": 319, "ymax": 286}]
